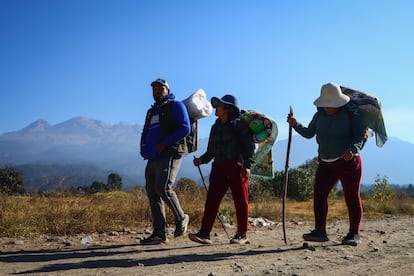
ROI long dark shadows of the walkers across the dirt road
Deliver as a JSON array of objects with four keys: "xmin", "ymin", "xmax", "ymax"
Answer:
[{"xmin": 0, "ymin": 240, "xmax": 318, "ymax": 274}]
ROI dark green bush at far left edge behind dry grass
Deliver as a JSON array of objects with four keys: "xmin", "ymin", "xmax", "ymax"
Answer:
[{"xmin": 0, "ymin": 166, "xmax": 24, "ymax": 195}]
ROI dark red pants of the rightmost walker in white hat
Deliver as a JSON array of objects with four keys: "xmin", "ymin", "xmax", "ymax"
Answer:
[{"xmin": 313, "ymin": 156, "xmax": 362, "ymax": 234}]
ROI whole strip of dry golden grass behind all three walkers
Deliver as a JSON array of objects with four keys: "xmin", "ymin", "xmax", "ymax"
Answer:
[{"xmin": 0, "ymin": 189, "xmax": 414, "ymax": 237}]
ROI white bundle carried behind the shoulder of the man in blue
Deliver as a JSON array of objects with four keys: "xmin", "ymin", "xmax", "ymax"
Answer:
[{"xmin": 183, "ymin": 89, "xmax": 213, "ymax": 121}]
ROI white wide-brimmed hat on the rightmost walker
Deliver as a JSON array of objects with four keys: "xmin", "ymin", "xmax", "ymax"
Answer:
[{"xmin": 313, "ymin": 82, "xmax": 350, "ymax": 107}]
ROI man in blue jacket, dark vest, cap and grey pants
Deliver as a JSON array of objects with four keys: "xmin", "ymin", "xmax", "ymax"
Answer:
[{"xmin": 140, "ymin": 79, "xmax": 190, "ymax": 244}]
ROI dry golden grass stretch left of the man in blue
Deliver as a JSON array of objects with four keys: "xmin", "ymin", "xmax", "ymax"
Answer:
[{"xmin": 0, "ymin": 191, "xmax": 150, "ymax": 237}]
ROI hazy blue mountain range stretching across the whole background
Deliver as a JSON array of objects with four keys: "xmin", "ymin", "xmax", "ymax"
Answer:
[{"xmin": 0, "ymin": 117, "xmax": 414, "ymax": 190}]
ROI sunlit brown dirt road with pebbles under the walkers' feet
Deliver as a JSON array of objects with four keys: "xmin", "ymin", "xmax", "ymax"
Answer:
[{"xmin": 0, "ymin": 217, "xmax": 414, "ymax": 276}]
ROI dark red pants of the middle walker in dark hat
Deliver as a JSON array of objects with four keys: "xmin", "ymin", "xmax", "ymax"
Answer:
[{"xmin": 200, "ymin": 160, "xmax": 249, "ymax": 234}]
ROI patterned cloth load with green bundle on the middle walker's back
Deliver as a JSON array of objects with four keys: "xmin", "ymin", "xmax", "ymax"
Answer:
[{"xmin": 240, "ymin": 110, "xmax": 278, "ymax": 178}]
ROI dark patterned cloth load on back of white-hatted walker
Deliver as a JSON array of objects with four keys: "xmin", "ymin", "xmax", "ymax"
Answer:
[{"xmin": 341, "ymin": 86, "xmax": 388, "ymax": 147}]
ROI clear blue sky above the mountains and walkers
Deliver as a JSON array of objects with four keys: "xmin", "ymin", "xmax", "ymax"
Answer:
[{"xmin": 0, "ymin": 0, "xmax": 414, "ymax": 143}]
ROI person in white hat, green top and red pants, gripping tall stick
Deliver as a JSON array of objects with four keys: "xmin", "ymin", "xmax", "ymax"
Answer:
[{"xmin": 287, "ymin": 83, "xmax": 365, "ymax": 246}]
